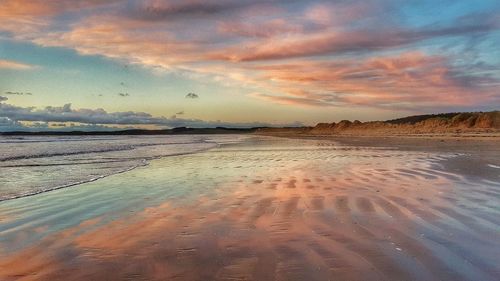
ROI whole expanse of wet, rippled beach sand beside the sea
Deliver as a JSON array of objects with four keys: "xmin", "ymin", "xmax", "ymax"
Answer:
[{"xmin": 0, "ymin": 137, "xmax": 500, "ymax": 280}]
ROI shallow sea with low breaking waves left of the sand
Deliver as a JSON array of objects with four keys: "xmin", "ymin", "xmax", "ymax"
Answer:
[{"xmin": 0, "ymin": 136, "xmax": 246, "ymax": 200}]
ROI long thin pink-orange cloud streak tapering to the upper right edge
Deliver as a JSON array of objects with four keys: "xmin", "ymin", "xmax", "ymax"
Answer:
[{"xmin": 210, "ymin": 19, "xmax": 496, "ymax": 61}]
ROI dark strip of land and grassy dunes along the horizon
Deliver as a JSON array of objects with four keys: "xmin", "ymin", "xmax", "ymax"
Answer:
[{"xmin": 0, "ymin": 111, "xmax": 500, "ymax": 136}]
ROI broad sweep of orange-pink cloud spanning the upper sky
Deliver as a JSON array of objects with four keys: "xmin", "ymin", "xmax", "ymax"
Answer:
[{"xmin": 0, "ymin": 0, "xmax": 500, "ymax": 112}]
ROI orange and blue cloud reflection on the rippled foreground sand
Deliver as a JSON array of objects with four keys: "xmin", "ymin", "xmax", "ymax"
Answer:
[{"xmin": 0, "ymin": 138, "xmax": 500, "ymax": 280}]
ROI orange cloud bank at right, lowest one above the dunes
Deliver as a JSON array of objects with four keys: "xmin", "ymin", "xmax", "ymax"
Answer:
[{"xmin": 248, "ymin": 52, "xmax": 498, "ymax": 109}]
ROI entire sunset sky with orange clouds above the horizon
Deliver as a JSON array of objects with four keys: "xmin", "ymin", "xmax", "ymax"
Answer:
[{"xmin": 0, "ymin": 0, "xmax": 500, "ymax": 131}]
